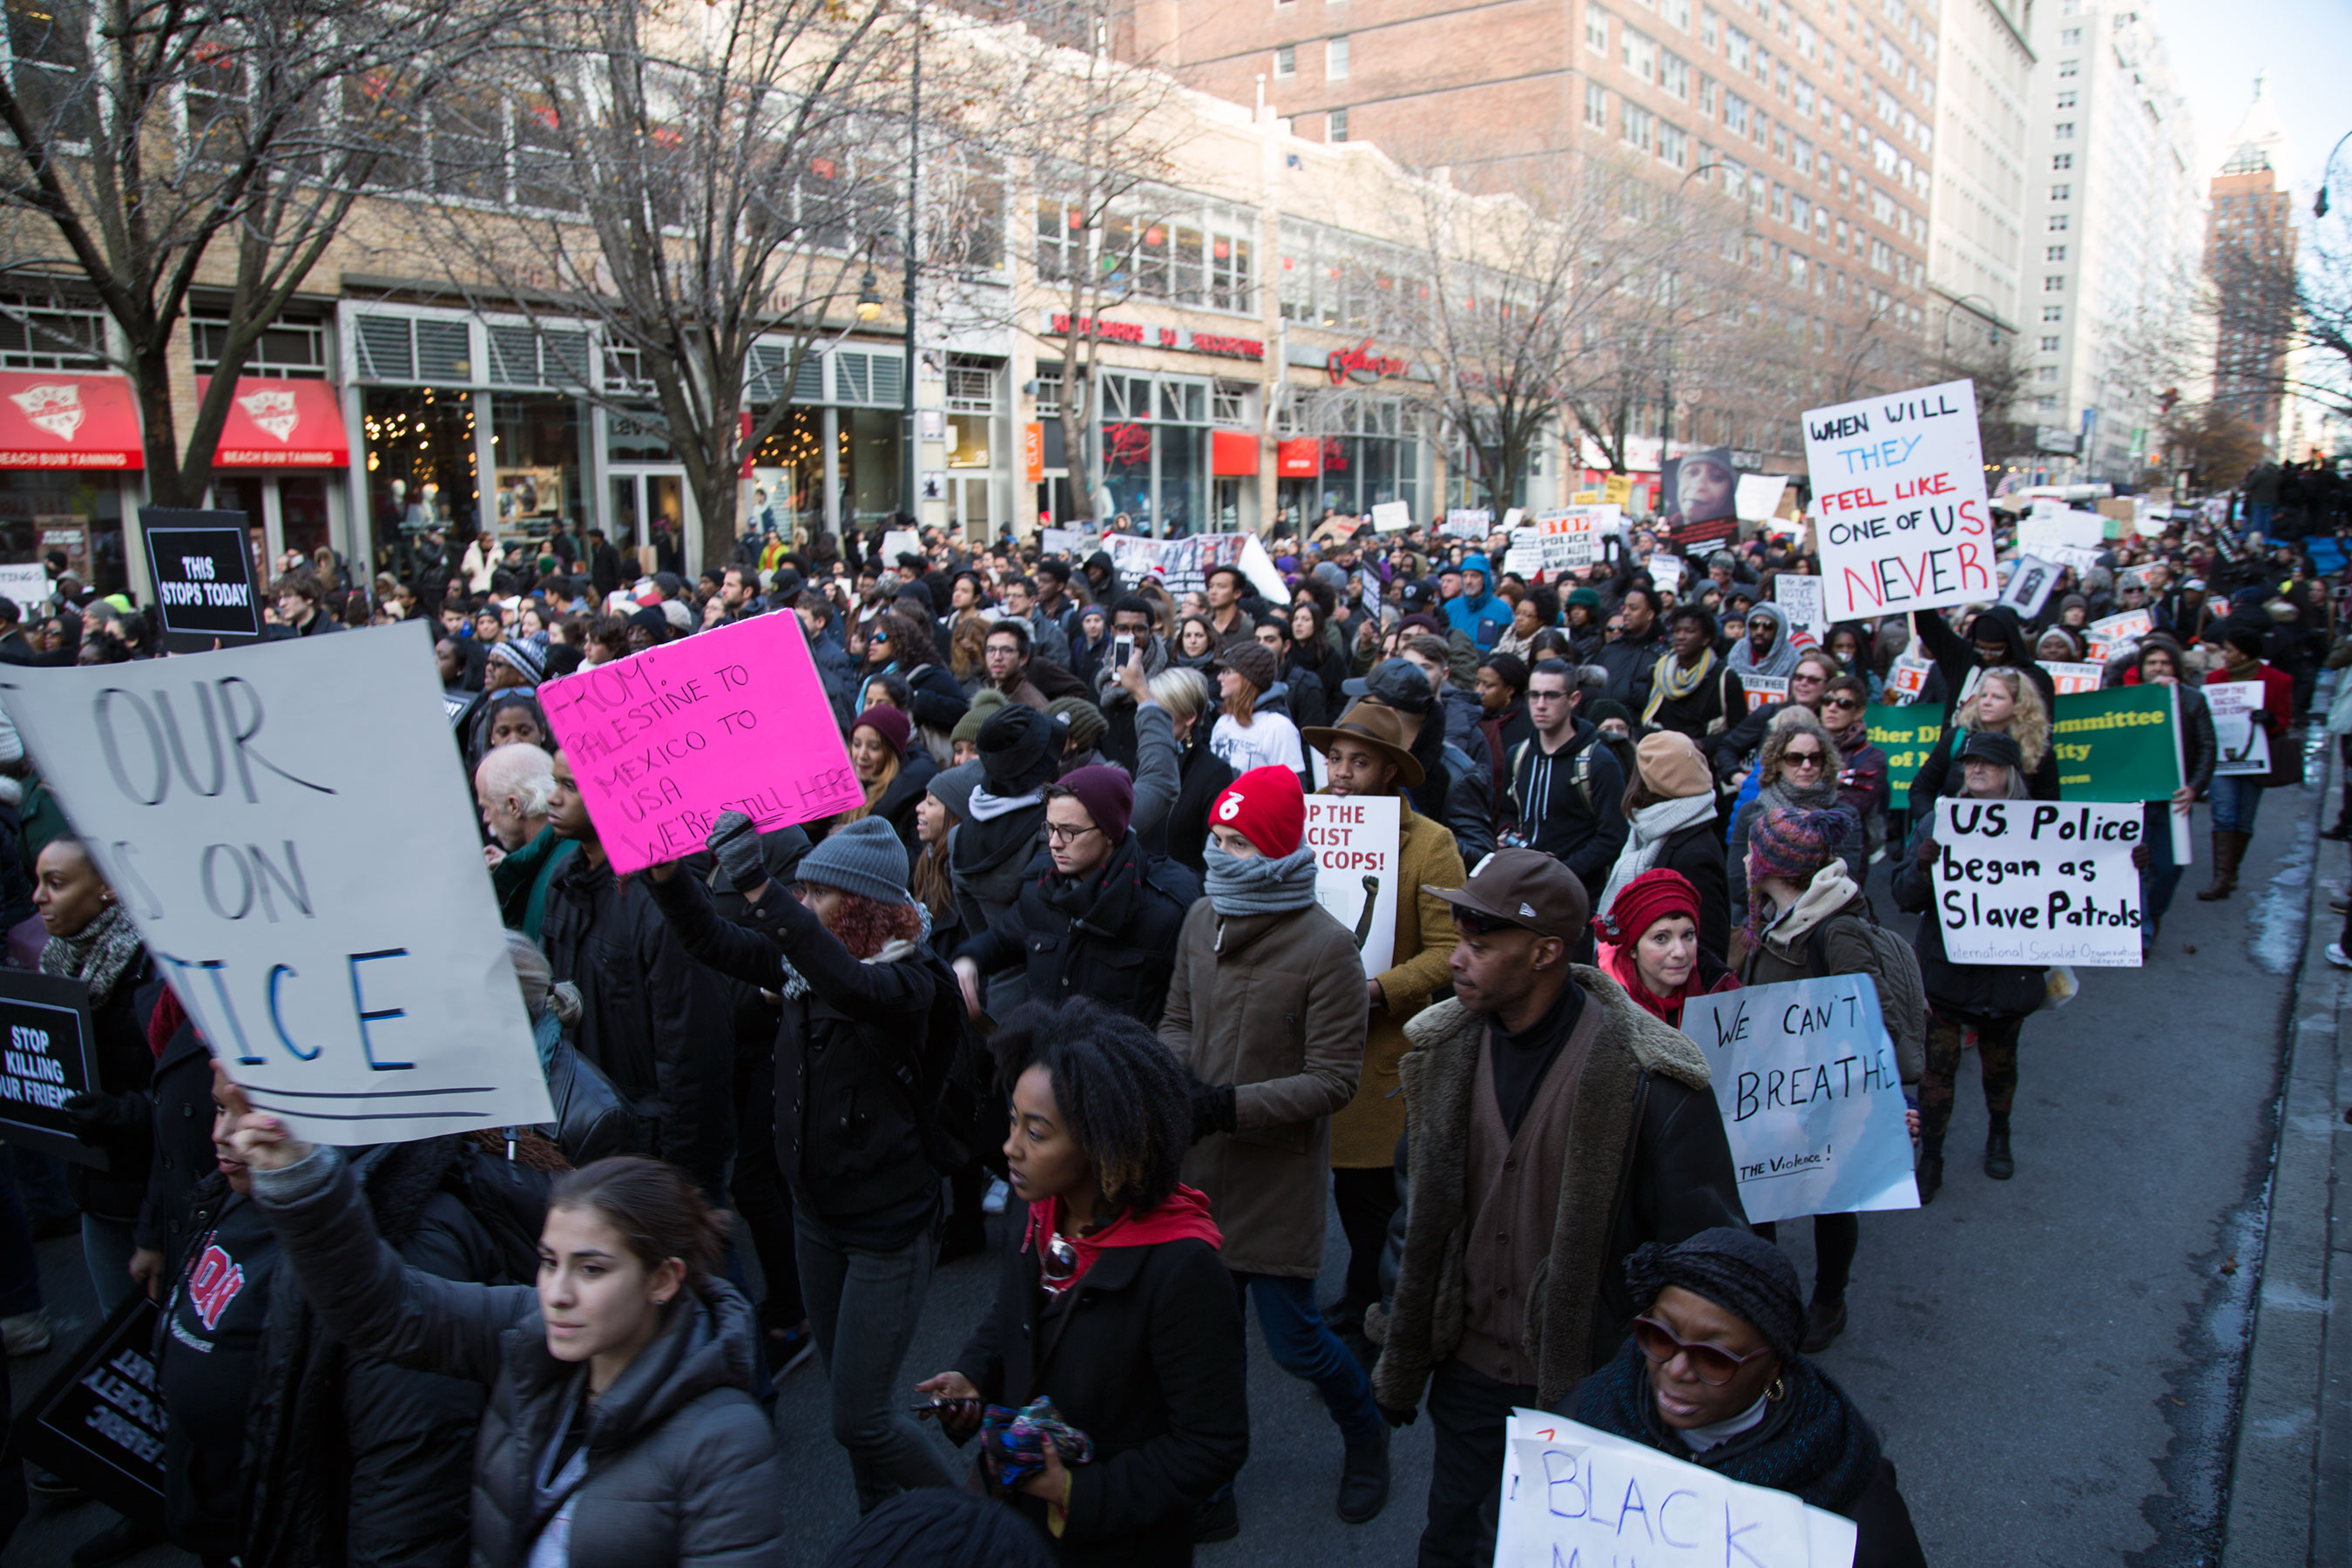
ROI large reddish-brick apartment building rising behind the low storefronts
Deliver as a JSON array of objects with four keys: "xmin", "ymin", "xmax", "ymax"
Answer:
[{"xmin": 1115, "ymin": 0, "xmax": 1937, "ymax": 468}]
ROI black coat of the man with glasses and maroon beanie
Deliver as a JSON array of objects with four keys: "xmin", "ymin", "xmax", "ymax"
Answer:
[{"xmin": 955, "ymin": 832, "xmax": 1200, "ymax": 1027}]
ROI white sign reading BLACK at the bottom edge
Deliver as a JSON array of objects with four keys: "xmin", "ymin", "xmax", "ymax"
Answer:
[{"xmin": 1494, "ymin": 1410, "xmax": 1858, "ymax": 1568}]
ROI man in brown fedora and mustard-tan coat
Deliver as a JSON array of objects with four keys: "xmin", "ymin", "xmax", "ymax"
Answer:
[{"xmin": 1301, "ymin": 698, "xmax": 1463, "ymax": 1354}]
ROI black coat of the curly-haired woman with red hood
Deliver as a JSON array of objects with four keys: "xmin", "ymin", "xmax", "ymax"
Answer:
[{"xmin": 955, "ymin": 1239, "xmax": 1249, "ymax": 1568}]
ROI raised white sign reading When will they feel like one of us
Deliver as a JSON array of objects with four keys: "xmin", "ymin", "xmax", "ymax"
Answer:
[{"xmin": 1804, "ymin": 381, "xmax": 1995, "ymax": 620}]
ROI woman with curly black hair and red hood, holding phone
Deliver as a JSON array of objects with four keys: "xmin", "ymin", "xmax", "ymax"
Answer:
[{"xmin": 917, "ymin": 997, "xmax": 1249, "ymax": 1565}]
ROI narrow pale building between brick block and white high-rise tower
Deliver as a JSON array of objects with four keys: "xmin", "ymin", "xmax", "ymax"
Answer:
[{"xmin": 1926, "ymin": 0, "xmax": 2035, "ymax": 362}]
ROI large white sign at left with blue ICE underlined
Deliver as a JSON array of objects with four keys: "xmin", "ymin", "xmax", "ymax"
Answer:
[{"xmin": 0, "ymin": 625, "xmax": 553, "ymax": 1143}]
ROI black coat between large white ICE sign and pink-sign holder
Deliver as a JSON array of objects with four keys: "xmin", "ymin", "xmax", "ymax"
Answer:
[{"xmin": 541, "ymin": 851, "xmax": 733, "ymax": 1192}]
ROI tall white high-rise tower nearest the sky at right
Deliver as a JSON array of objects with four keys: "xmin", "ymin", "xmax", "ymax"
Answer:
[{"xmin": 2016, "ymin": 0, "xmax": 2204, "ymax": 482}]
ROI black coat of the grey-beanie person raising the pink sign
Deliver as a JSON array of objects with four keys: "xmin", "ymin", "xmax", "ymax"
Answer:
[{"xmin": 649, "ymin": 877, "xmax": 955, "ymax": 1222}]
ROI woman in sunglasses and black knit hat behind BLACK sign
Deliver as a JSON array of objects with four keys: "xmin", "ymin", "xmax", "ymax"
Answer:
[{"xmin": 1569, "ymin": 1229, "xmax": 1926, "ymax": 1568}]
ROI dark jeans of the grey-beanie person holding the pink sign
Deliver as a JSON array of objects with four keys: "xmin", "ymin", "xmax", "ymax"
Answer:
[{"xmin": 793, "ymin": 1206, "xmax": 955, "ymax": 1514}]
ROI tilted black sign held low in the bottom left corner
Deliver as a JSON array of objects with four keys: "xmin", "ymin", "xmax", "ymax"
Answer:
[{"xmin": 14, "ymin": 1291, "xmax": 165, "ymax": 1528}]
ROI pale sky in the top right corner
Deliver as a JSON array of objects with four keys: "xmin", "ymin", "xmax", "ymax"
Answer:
[{"xmin": 2140, "ymin": 0, "xmax": 2352, "ymax": 199}]
